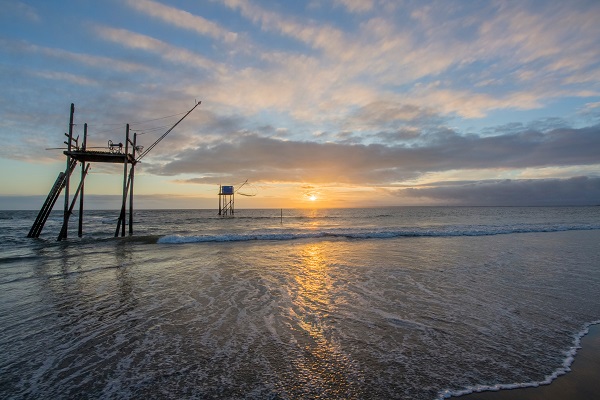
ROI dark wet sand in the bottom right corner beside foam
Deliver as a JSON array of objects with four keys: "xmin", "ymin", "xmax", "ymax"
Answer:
[{"xmin": 458, "ymin": 325, "xmax": 600, "ymax": 400}]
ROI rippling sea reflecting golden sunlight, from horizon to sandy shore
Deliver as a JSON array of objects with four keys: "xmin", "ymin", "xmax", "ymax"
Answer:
[{"xmin": 0, "ymin": 207, "xmax": 600, "ymax": 400}]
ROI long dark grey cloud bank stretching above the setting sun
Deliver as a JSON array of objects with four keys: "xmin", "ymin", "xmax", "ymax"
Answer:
[{"xmin": 150, "ymin": 126, "xmax": 600, "ymax": 185}]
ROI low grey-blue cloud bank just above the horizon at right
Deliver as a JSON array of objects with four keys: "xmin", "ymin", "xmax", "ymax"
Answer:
[{"xmin": 394, "ymin": 176, "xmax": 600, "ymax": 206}]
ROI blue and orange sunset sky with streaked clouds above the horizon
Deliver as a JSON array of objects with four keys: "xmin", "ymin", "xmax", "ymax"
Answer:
[{"xmin": 0, "ymin": 0, "xmax": 600, "ymax": 210}]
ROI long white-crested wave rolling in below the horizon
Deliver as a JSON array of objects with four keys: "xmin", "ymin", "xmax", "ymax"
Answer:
[{"xmin": 157, "ymin": 225, "xmax": 600, "ymax": 244}]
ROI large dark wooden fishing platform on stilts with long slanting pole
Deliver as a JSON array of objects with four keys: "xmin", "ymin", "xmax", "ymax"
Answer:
[{"xmin": 27, "ymin": 102, "xmax": 201, "ymax": 240}]
